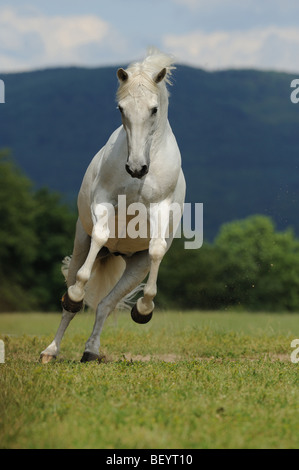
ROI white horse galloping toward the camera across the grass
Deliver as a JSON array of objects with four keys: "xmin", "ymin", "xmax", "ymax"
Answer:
[{"xmin": 41, "ymin": 50, "xmax": 186, "ymax": 363}]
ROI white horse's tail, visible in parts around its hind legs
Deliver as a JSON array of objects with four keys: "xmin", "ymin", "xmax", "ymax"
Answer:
[{"xmin": 61, "ymin": 255, "xmax": 144, "ymax": 310}]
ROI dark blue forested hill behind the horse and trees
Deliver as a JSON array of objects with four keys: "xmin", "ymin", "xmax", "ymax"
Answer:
[{"xmin": 0, "ymin": 66, "xmax": 299, "ymax": 238}]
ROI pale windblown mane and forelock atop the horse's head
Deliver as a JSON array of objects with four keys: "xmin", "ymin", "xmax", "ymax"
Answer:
[{"xmin": 117, "ymin": 48, "xmax": 175, "ymax": 101}]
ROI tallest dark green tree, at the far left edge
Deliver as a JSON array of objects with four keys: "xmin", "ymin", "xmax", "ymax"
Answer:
[{"xmin": 0, "ymin": 150, "xmax": 38, "ymax": 311}]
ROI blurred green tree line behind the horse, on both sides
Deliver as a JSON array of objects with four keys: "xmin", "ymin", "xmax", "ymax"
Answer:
[{"xmin": 0, "ymin": 150, "xmax": 299, "ymax": 312}]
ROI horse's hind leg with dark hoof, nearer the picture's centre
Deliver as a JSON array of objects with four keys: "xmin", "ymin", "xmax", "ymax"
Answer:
[{"xmin": 81, "ymin": 251, "xmax": 150, "ymax": 362}]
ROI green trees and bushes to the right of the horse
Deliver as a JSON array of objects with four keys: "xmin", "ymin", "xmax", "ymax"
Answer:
[{"xmin": 157, "ymin": 215, "xmax": 299, "ymax": 311}]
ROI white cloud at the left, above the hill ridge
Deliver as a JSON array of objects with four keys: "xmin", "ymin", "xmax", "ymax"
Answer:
[{"xmin": 0, "ymin": 8, "xmax": 124, "ymax": 71}]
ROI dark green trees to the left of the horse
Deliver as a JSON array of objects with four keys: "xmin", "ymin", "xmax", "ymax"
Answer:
[{"xmin": 0, "ymin": 151, "xmax": 76, "ymax": 312}]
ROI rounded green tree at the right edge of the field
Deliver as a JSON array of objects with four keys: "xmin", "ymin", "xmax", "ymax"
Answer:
[{"xmin": 215, "ymin": 215, "xmax": 299, "ymax": 310}]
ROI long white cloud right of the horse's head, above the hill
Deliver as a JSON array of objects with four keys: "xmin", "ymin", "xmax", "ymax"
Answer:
[{"xmin": 163, "ymin": 26, "xmax": 299, "ymax": 72}]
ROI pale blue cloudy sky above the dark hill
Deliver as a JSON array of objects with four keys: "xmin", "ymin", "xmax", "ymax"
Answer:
[{"xmin": 0, "ymin": 0, "xmax": 299, "ymax": 73}]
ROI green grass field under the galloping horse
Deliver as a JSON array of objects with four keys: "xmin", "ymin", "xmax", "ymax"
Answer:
[{"xmin": 0, "ymin": 312, "xmax": 299, "ymax": 449}]
